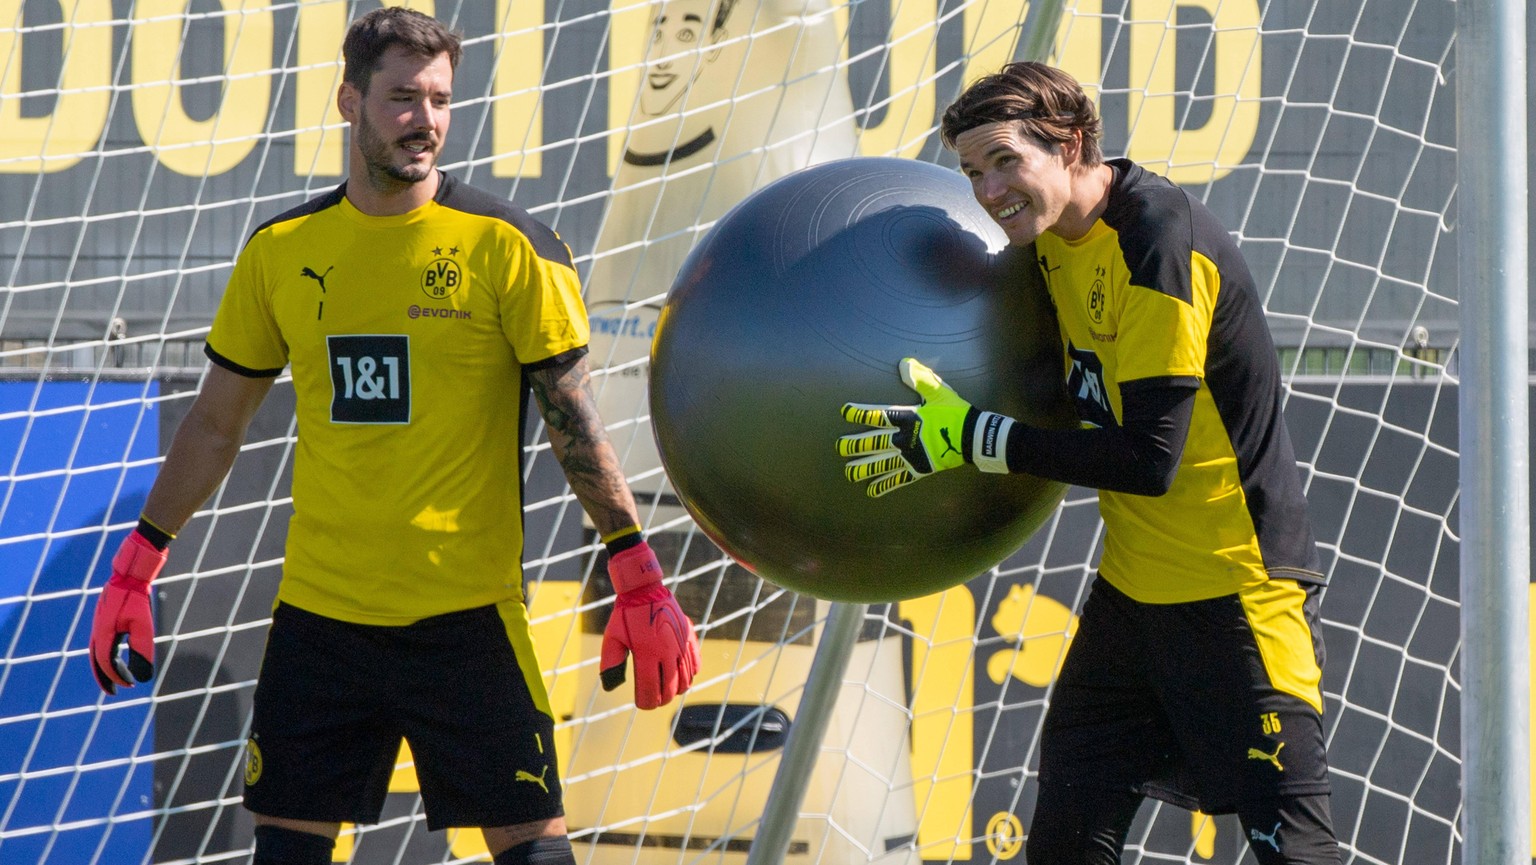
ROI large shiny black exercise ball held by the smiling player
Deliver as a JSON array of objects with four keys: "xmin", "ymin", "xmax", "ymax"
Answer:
[{"xmin": 650, "ymin": 158, "xmax": 1075, "ymax": 602}]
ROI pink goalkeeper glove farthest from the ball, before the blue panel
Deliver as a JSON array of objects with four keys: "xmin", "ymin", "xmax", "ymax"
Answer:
[{"xmin": 91, "ymin": 529, "xmax": 166, "ymax": 694}]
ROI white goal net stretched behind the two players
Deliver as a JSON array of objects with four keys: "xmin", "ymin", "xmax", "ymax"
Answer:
[{"xmin": 0, "ymin": 0, "xmax": 1474, "ymax": 865}]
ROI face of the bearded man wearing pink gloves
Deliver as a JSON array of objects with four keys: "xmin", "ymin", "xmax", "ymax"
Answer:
[{"xmin": 343, "ymin": 46, "xmax": 453, "ymax": 186}]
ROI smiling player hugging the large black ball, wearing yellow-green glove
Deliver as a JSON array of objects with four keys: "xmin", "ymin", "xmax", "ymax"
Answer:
[{"xmin": 839, "ymin": 63, "xmax": 1339, "ymax": 865}]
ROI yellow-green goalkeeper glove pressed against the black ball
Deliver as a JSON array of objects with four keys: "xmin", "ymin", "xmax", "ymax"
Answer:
[{"xmin": 837, "ymin": 358, "xmax": 1014, "ymax": 498}]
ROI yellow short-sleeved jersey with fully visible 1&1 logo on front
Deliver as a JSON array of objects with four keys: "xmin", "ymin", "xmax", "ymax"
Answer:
[{"xmin": 206, "ymin": 175, "xmax": 588, "ymax": 625}]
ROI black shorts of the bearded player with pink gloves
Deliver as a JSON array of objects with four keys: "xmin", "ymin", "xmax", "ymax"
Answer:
[{"xmin": 246, "ymin": 601, "xmax": 564, "ymax": 830}]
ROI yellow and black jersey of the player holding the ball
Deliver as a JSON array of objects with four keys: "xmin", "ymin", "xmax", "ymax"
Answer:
[{"xmin": 1035, "ymin": 160, "xmax": 1322, "ymax": 604}]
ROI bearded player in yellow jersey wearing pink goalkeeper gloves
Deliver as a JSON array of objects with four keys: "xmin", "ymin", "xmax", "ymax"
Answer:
[{"xmin": 91, "ymin": 8, "xmax": 699, "ymax": 865}]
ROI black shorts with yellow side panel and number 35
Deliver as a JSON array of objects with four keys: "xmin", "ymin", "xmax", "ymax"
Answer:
[{"xmin": 1040, "ymin": 578, "xmax": 1329, "ymax": 814}]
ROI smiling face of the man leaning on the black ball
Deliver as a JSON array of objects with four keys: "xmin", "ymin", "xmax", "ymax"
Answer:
[{"xmin": 955, "ymin": 121, "xmax": 1075, "ymax": 246}]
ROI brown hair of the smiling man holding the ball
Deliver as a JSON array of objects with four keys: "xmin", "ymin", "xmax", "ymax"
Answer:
[{"xmin": 938, "ymin": 61, "xmax": 1104, "ymax": 166}]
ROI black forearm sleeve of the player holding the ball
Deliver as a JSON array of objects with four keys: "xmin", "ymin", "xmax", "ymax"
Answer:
[{"xmin": 1008, "ymin": 376, "xmax": 1200, "ymax": 496}]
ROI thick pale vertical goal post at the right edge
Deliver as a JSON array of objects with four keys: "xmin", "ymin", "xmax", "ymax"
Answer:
[{"xmin": 1456, "ymin": 3, "xmax": 1531, "ymax": 865}]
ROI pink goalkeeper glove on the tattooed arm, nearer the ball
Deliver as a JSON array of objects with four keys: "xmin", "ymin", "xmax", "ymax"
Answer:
[{"xmin": 599, "ymin": 541, "xmax": 699, "ymax": 708}]
